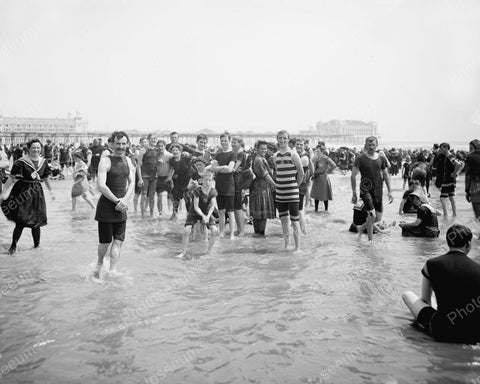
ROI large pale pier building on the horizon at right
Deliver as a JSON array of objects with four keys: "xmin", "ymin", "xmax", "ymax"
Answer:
[{"xmin": 300, "ymin": 120, "xmax": 378, "ymax": 143}]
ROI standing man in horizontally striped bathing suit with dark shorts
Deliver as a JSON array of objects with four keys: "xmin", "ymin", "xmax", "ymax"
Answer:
[{"xmin": 273, "ymin": 131, "xmax": 303, "ymax": 251}]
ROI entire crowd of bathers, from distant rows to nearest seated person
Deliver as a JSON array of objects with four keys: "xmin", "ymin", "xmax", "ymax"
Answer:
[{"xmin": 0, "ymin": 131, "xmax": 480, "ymax": 342}]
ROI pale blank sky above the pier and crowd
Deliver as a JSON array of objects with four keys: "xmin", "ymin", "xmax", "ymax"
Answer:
[{"xmin": 0, "ymin": 0, "xmax": 480, "ymax": 142}]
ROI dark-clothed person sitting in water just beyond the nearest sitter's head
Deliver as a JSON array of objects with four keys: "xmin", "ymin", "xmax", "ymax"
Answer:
[{"xmin": 399, "ymin": 188, "xmax": 440, "ymax": 237}]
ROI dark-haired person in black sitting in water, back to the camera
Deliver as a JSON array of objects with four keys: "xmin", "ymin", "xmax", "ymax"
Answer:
[{"xmin": 402, "ymin": 225, "xmax": 480, "ymax": 344}]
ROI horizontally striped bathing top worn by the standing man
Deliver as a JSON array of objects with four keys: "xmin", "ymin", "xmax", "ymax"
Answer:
[{"xmin": 275, "ymin": 151, "xmax": 300, "ymax": 203}]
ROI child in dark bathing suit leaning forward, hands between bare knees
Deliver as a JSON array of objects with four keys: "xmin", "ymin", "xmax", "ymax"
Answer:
[{"xmin": 177, "ymin": 172, "xmax": 218, "ymax": 258}]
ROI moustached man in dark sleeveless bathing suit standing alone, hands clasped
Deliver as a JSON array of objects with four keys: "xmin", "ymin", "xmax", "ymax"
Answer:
[{"xmin": 93, "ymin": 131, "xmax": 135, "ymax": 279}]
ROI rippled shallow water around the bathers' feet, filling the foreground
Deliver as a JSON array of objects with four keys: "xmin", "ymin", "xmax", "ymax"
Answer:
[{"xmin": 0, "ymin": 175, "xmax": 480, "ymax": 383}]
